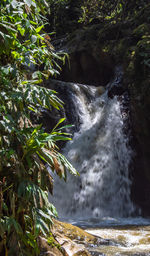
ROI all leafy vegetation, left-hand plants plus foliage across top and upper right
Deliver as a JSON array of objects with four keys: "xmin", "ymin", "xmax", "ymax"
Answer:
[{"xmin": 0, "ymin": 0, "xmax": 150, "ymax": 256}]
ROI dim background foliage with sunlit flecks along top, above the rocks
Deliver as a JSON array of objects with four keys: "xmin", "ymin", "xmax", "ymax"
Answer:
[{"xmin": 48, "ymin": 0, "xmax": 149, "ymax": 35}]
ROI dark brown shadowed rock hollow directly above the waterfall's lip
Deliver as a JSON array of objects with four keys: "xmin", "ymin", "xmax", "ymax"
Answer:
[{"xmin": 59, "ymin": 49, "xmax": 113, "ymax": 86}]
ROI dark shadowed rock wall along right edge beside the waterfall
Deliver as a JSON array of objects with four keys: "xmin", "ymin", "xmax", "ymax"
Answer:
[{"xmin": 125, "ymin": 21, "xmax": 150, "ymax": 216}]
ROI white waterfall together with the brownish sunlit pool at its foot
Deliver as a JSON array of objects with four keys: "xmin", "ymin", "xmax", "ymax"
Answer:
[{"xmin": 51, "ymin": 68, "xmax": 150, "ymax": 256}]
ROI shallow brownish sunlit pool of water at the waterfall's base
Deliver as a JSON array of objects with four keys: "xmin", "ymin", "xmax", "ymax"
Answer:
[{"xmin": 63, "ymin": 217, "xmax": 150, "ymax": 256}]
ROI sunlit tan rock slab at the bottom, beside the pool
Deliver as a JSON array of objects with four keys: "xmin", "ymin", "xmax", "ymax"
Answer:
[{"xmin": 39, "ymin": 220, "xmax": 110, "ymax": 256}]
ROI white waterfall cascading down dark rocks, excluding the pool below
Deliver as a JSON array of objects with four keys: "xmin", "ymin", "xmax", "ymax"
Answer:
[{"xmin": 49, "ymin": 67, "xmax": 134, "ymax": 219}]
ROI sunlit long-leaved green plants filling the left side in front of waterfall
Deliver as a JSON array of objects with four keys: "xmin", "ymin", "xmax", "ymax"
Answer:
[{"xmin": 0, "ymin": 0, "xmax": 77, "ymax": 256}]
